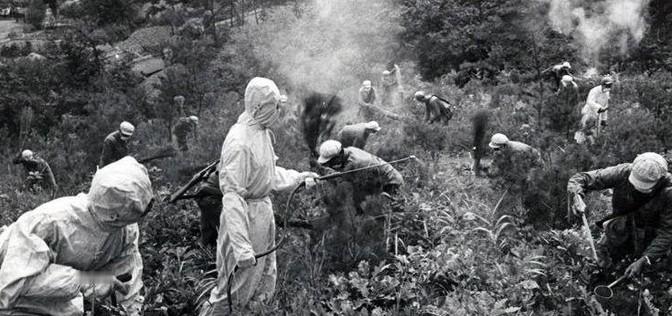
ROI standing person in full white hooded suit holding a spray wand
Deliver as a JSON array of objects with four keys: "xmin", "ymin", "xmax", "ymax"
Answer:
[{"xmin": 200, "ymin": 77, "xmax": 317, "ymax": 316}]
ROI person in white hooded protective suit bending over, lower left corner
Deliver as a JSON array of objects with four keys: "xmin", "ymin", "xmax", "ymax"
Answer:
[{"xmin": 0, "ymin": 157, "xmax": 153, "ymax": 315}]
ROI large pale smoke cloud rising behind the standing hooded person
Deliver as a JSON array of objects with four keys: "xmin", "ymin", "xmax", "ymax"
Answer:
[{"xmin": 234, "ymin": 0, "xmax": 401, "ymax": 95}]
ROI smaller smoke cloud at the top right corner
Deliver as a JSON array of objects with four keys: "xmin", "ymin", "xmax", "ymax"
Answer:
[{"xmin": 542, "ymin": 0, "xmax": 650, "ymax": 63}]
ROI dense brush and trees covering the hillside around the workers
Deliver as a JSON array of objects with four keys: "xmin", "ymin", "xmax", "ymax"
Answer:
[{"xmin": 0, "ymin": 0, "xmax": 672, "ymax": 315}]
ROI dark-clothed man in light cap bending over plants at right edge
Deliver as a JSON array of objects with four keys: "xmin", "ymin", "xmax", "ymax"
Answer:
[{"xmin": 567, "ymin": 153, "xmax": 672, "ymax": 277}]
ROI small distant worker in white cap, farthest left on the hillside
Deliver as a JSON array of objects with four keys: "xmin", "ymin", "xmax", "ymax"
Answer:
[{"xmin": 13, "ymin": 149, "xmax": 58, "ymax": 198}]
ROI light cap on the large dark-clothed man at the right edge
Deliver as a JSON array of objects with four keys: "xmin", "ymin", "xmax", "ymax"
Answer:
[{"xmin": 628, "ymin": 152, "xmax": 667, "ymax": 192}]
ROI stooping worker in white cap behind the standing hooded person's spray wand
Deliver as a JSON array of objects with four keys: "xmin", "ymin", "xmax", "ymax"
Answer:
[{"xmin": 317, "ymin": 140, "xmax": 404, "ymax": 211}]
